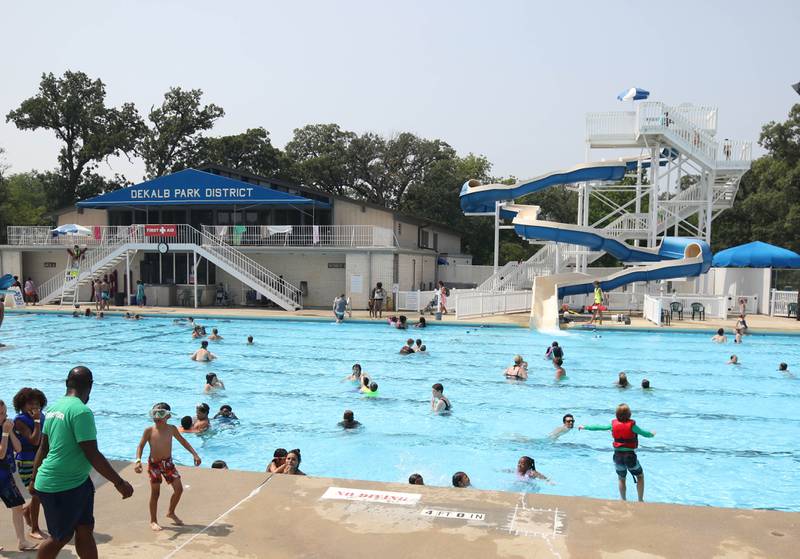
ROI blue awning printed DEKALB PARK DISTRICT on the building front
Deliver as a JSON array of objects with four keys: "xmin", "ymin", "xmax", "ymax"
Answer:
[{"xmin": 78, "ymin": 169, "xmax": 329, "ymax": 208}]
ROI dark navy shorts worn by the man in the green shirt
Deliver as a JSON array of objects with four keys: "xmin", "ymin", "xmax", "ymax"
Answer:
[{"xmin": 36, "ymin": 477, "xmax": 94, "ymax": 542}]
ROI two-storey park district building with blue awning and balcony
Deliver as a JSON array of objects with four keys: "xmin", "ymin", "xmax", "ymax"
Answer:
[{"xmin": 0, "ymin": 166, "xmax": 471, "ymax": 309}]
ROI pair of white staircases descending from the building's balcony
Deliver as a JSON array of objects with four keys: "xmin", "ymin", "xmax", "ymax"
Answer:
[{"xmin": 39, "ymin": 224, "xmax": 302, "ymax": 311}]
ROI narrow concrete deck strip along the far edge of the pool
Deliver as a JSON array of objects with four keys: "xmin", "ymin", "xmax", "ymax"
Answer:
[{"xmin": 6, "ymin": 305, "xmax": 800, "ymax": 334}]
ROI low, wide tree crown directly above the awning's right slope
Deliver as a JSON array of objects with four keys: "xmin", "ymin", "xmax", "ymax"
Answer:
[{"xmin": 184, "ymin": 128, "xmax": 290, "ymax": 178}]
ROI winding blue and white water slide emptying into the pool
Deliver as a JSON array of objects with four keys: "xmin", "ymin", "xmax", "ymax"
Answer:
[{"xmin": 461, "ymin": 153, "xmax": 711, "ymax": 330}]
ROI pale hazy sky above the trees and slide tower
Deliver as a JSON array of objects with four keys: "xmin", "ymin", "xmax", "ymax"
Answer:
[{"xmin": 0, "ymin": 0, "xmax": 800, "ymax": 181}]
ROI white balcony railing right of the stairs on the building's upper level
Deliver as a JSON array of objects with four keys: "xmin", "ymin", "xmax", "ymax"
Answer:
[{"xmin": 198, "ymin": 225, "xmax": 397, "ymax": 247}]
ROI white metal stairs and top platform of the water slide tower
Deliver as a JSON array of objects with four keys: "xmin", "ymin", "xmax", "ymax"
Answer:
[{"xmin": 479, "ymin": 102, "xmax": 751, "ymax": 291}]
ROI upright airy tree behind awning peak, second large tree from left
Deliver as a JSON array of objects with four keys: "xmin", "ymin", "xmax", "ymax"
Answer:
[{"xmin": 138, "ymin": 87, "xmax": 225, "ymax": 178}]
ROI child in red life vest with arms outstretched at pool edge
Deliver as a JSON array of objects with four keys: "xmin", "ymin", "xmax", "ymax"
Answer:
[{"xmin": 578, "ymin": 404, "xmax": 656, "ymax": 501}]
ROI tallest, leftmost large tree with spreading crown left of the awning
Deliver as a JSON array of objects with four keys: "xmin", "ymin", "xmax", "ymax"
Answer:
[{"xmin": 6, "ymin": 70, "xmax": 143, "ymax": 204}]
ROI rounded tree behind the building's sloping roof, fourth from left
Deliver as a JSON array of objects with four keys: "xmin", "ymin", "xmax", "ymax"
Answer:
[{"xmin": 285, "ymin": 124, "xmax": 356, "ymax": 196}]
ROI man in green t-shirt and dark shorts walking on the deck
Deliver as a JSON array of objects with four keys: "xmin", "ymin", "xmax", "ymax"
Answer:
[{"xmin": 30, "ymin": 366, "xmax": 133, "ymax": 559}]
